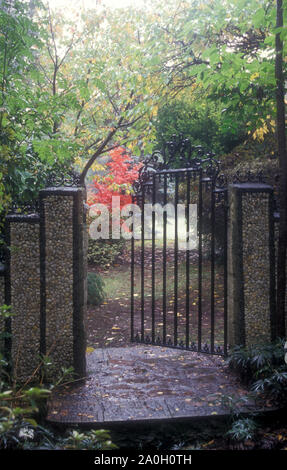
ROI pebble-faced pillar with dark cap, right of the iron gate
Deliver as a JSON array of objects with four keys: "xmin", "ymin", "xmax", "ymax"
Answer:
[{"xmin": 228, "ymin": 183, "xmax": 275, "ymax": 346}]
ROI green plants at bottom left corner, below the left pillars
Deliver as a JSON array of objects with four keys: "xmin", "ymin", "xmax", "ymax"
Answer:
[{"xmin": 0, "ymin": 305, "xmax": 116, "ymax": 450}]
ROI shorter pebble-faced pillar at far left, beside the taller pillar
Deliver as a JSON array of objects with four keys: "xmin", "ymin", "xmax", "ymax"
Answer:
[{"xmin": 6, "ymin": 214, "xmax": 41, "ymax": 382}]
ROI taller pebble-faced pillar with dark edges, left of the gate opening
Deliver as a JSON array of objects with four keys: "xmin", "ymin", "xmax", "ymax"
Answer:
[{"xmin": 40, "ymin": 187, "xmax": 86, "ymax": 377}]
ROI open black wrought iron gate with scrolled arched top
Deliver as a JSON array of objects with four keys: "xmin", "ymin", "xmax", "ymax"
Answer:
[{"xmin": 131, "ymin": 138, "xmax": 228, "ymax": 354}]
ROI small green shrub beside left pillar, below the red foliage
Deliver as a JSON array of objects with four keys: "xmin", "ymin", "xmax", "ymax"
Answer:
[{"xmin": 88, "ymin": 238, "xmax": 125, "ymax": 268}]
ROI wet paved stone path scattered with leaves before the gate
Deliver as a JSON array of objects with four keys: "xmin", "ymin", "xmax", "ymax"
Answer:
[{"xmin": 48, "ymin": 345, "xmax": 253, "ymax": 425}]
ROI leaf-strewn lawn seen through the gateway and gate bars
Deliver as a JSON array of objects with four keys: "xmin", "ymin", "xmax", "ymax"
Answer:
[{"xmin": 87, "ymin": 240, "xmax": 226, "ymax": 347}]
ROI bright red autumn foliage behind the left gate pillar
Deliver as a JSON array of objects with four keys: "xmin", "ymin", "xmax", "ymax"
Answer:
[{"xmin": 88, "ymin": 147, "xmax": 142, "ymax": 210}]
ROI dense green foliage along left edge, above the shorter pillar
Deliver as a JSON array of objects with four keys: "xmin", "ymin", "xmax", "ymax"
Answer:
[{"xmin": 0, "ymin": 0, "xmax": 77, "ymax": 212}]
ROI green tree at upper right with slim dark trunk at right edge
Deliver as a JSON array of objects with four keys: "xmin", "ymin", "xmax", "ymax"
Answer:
[{"xmin": 147, "ymin": 0, "xmax": 287, "ymax": 336}]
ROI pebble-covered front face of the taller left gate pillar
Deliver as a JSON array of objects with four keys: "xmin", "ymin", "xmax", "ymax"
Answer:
[{"xmin": 44, "ymin": 195, "xmax": 73, "ymax": 378}]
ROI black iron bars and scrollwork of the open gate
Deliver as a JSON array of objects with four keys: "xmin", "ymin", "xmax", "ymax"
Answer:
[{"xmin": 131, "ymin": 139, "xmax": 228, "ymax": 355}]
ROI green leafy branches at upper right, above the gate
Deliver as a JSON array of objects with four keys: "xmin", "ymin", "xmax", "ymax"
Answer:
[{"xmin": 148, "ymin": 0, "xmax": 287, "ymax": 140}]
